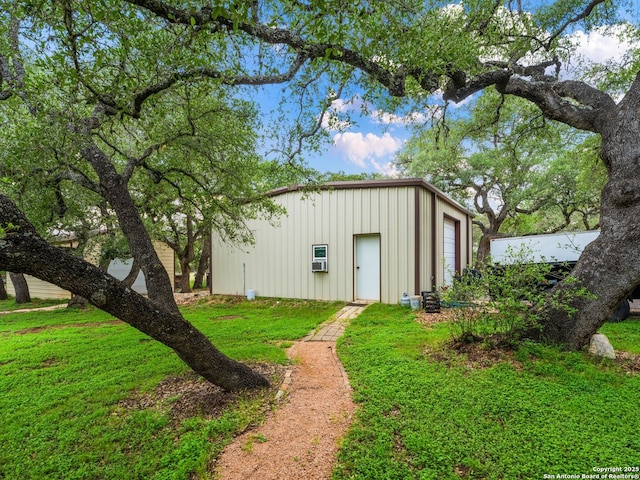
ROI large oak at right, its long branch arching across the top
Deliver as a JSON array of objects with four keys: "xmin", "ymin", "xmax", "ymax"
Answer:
[{"xmin": 114, "ymin": 0, "xmax": 640, "ymax": 348}]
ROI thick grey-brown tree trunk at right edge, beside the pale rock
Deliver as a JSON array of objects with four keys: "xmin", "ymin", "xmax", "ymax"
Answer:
[{"xmin": 516, "ymin": 74, "xmax": 640, "ymax": 349}]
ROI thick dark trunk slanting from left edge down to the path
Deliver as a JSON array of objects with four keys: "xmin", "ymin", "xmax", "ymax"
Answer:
[{"xmin": 0, "ymin": 195, "xmax": 269, "ymax": 390}]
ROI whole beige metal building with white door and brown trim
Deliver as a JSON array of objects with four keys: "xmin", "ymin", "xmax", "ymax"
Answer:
[{"xmin": 211, "ymin": 179, "xmax": 473, "ymax": 303}]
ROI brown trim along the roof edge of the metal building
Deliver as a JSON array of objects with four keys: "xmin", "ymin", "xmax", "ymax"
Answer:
[{"xmin": 267, "ymin": 178, "xmax": 475, "ymax": 217}]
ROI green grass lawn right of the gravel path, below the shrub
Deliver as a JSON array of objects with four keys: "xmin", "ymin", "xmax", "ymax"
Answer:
[{"xmin": 334, "ymin": 305, "xmax": 640, "ymax": 480}]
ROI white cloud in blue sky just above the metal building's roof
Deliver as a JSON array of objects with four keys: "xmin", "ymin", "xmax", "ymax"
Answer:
[{"xmin": 333, "ymin": 132, "xmax": 402, "ymax": 168}]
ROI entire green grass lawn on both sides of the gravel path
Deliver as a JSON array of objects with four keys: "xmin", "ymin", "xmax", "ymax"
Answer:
[{"xmin": 0, "ymin": 299, "xmax": 640, "ymax": 480}]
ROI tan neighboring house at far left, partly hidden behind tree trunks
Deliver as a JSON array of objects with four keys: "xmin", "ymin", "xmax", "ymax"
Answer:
[{"xmin": 7, "ymin": 242, "xmax": 175, "ymax": 299}]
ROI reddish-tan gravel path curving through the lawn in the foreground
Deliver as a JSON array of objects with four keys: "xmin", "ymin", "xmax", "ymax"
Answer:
[{"xmin": 216, "ymin": 341, "xmax": 355, "ymax": 480}]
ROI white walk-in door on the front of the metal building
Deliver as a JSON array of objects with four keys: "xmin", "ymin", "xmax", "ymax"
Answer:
[{"xmin": 355, "ymin": 235, "xmax": 380, "ymax": 301}]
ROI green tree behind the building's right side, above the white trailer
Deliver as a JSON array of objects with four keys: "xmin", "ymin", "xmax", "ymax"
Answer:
[{"xmin": 396, "ymin": 89, "xmax": 606, "ymax": 263}]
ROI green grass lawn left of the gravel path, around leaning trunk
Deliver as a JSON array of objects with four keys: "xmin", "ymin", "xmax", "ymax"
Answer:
[{"xmin": 0, "ymin": 300, "xmax": 342, "ymax": 480}]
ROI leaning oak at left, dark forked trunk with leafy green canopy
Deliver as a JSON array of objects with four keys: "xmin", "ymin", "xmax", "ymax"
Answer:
[{"xmin": 0, "ymin": 2, "xmax": 284, "ymax": 389}]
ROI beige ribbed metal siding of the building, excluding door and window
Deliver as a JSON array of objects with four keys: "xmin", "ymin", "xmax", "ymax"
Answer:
[{"xmin": 212, "ymin": 186, "xmax": 469, "ymax": 303}]
